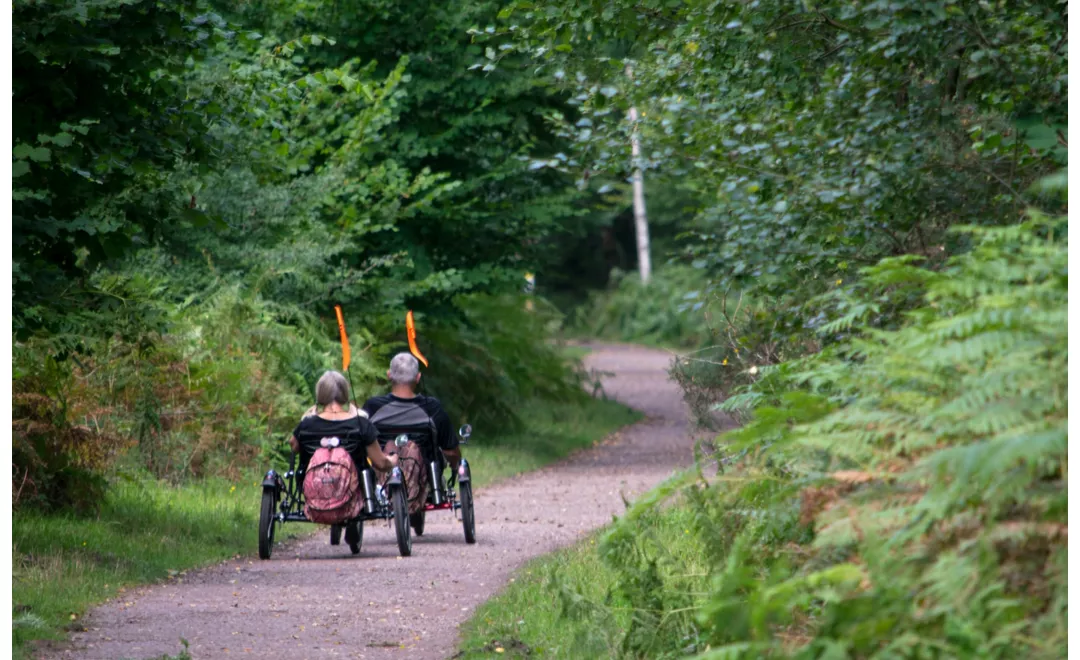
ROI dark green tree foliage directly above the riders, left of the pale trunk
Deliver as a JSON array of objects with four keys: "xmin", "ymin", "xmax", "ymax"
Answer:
[{"xmin": 230, "ymin": 0, "xmax": 600, "ymax": 312}]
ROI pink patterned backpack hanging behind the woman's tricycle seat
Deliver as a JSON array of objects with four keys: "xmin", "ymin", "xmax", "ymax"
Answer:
[{"xmin": 303, "ymin": 447, "xmax": 363, "ymax": 525}]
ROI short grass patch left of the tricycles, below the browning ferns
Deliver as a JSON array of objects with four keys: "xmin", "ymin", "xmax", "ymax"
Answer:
[{"xmin": 12, "ymin": 480, "xmax": 306, "ymax": 657}]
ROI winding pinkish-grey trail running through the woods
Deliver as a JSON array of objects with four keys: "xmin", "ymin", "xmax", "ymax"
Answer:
[{"xmin": 45, "ymin": 345, "xmax": 693, "ymax": 660}]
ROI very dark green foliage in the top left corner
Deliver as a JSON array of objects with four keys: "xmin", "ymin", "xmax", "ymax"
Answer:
[{"xmin": 12, "ymin": 0, "xmax": 248, "ymax": 333}]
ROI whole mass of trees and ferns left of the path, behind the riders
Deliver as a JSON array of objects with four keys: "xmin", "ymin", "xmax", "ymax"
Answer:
[{"xmin": 13, "ymin": 0, "xmax": 604, "ymax": 510}]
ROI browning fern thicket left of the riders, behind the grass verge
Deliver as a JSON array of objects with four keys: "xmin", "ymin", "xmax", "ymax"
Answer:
[{"xmin": 13, "ymin": 285, "xmax": 373, "ymax": 511}]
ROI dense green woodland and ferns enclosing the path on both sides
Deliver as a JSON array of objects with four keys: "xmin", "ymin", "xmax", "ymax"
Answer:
[{"xmin": 13, "ymin": 0, "xmax": 1068, "ymax": 659}]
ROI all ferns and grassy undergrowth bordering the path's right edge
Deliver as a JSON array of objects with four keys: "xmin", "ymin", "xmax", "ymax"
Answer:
[{"xmin": 462, "ymin": 205, "xmax": 1068, "ymax": 659}]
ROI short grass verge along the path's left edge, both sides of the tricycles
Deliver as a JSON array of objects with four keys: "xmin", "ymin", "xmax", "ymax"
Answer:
[{"xmin": 12, "ymin": 393, "xmax": 640, "ymax": 657}]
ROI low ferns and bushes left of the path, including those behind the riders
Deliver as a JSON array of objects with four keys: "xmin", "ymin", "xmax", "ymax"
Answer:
[{"xmin": 12, "ymin": 281, "xmax": 585, "ymax": 512}]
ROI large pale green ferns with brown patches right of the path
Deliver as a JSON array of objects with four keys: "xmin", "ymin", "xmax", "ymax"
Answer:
[{"xmin": 702, "ymin": 214, "xmax": 1068, "ymax": 658}]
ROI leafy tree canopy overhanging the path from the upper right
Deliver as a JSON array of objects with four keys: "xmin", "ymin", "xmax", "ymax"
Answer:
[{"xmin": 488, "ymin": 0, "xmax": 1067, "ymax": 319}]
